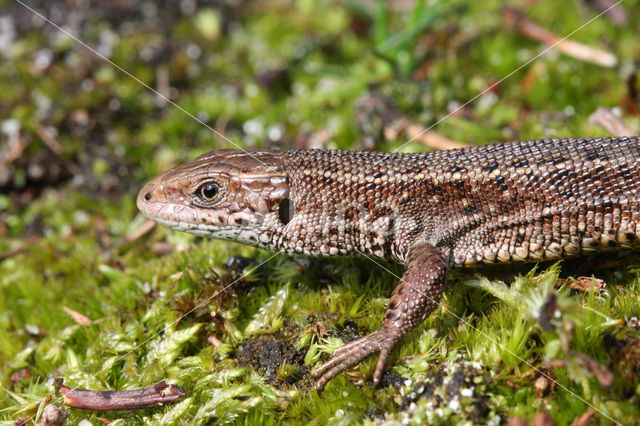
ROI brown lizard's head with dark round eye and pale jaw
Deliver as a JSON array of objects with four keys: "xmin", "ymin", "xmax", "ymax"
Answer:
[{"xmin": 137, "ymin": 150, "xmax": 290, "ymax": 248}]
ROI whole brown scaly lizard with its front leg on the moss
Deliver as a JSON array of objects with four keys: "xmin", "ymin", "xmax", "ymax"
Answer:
[{"xmin": 138, "ymin": 137, "xmax": 640, "ymax": 389}]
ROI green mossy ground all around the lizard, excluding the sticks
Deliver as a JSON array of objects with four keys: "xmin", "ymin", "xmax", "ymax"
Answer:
[{"xmin": 0, "ymin": 0, "xmax": 640, "ymax": 424}]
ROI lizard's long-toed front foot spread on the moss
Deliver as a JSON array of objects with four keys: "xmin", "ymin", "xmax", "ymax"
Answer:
[{"xmin": 313, "ymin": 326, "xmax": 402, "ymax": 391}]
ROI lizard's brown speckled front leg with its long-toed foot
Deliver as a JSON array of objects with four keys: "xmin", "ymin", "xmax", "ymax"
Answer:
[{"xmin": 314, "ymin": 243, "xmax": 448, "ymax": 390}]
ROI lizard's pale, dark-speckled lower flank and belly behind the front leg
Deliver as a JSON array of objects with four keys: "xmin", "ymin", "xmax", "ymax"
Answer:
[{"xmin": 452, "ymin": 201, "xmax": 640, "ymax": 266}]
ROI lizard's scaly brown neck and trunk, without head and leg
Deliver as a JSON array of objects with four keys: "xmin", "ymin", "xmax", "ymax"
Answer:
[{"xmin": 278, "ymin": 137, "xmax": 640, "ymax": 266}]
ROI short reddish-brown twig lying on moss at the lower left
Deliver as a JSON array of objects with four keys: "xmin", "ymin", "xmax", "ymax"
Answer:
[{"xmin": 59, "ymin": 380, "xmax": 187, "ymax": 411}]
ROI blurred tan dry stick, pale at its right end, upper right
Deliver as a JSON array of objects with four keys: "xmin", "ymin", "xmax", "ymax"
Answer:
[{"xmin": 502, "ymin": 7, "xmax": 618, "ymax": 68}]
